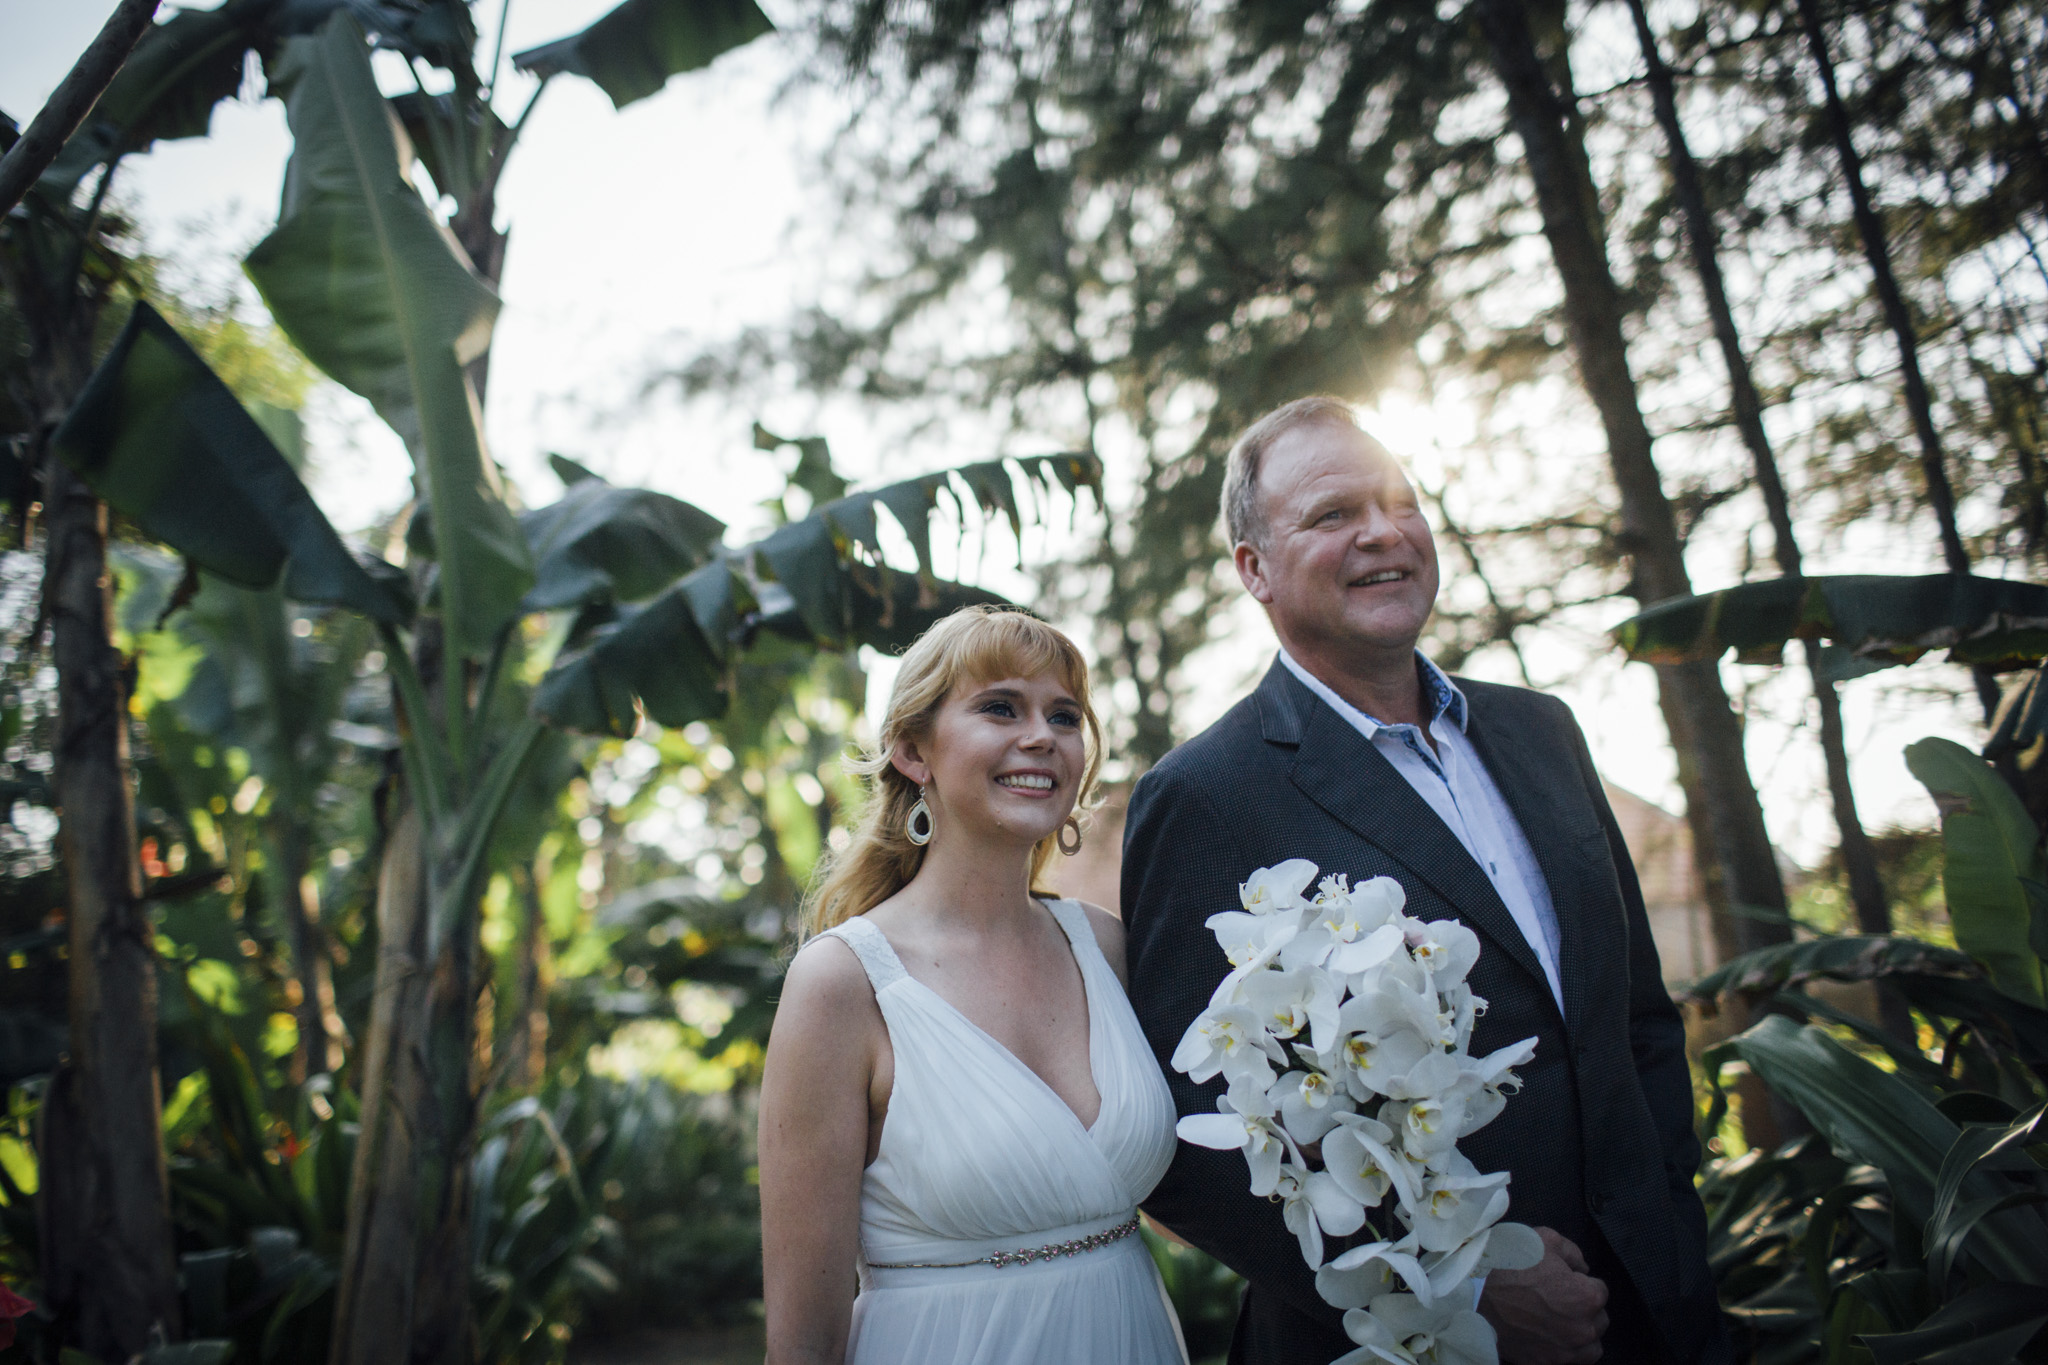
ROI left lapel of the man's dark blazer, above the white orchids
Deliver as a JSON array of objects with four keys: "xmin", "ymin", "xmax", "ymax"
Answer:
[{"xmin": 1260, "ymin": 663, "xmax": 1569, "ymax": 999}]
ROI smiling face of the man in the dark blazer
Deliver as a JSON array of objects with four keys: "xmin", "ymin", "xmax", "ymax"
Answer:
[{"xmin": 1237, "ymin": 426, "xmax": 1438, "ymax": 655}]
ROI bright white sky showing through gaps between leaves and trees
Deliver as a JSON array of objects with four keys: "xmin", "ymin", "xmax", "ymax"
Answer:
[{"xmin": 0, "ymin": 0, "xmax": 1980, "ymax": 860}]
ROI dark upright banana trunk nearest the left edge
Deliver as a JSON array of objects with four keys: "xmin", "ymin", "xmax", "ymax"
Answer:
[{"xmin": 37, "ymin": 456, "xmax": 180, "ymax": 1361}]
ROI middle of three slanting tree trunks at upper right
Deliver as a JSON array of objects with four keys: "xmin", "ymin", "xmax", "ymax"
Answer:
[{"xmin": 1628, "ymin": 0, "xmax": 1892, "ymax": 949}]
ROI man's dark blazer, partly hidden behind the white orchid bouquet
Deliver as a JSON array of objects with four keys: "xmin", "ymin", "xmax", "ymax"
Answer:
[{"xmin": 1122, "ymin": 661, "xmax": 1720, "ymax": 1365}]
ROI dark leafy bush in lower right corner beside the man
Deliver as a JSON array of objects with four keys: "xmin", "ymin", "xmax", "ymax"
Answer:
[{"xmin": 1692, "ymin": 741, "xmax": 2048, "ymax": 1365}]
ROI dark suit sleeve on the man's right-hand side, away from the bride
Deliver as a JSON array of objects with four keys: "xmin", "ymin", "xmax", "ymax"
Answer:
[{"xmin": 1567, "ymin": 716, "xmax": 1706, "ymax": 1252}]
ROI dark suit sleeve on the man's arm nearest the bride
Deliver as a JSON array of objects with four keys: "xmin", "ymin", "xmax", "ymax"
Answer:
[{"xmin": 1122, "ymin": 769, "xmax": 1341, "ymax": 1332}]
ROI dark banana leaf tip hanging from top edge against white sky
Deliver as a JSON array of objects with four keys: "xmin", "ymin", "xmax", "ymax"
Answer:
[{"xmin": 512, "ymin": 0, "xmax": 774, "ymax": 108}]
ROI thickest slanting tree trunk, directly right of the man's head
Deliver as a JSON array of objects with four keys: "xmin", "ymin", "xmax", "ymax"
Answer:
[{"xmin": 1473, "ymin": 0, "xmax": 1792, "ymax": 965}]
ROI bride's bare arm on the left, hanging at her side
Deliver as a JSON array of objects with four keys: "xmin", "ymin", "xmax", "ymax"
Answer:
[{"xmin": 760, "ymin": 939, "xmax": 887, "ymax": 1365}]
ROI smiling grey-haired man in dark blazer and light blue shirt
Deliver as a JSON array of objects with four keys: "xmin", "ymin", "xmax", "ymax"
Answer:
[{"xmin": 1122, "ymin": 397, "xmax": 1724, "ymax": 1365}]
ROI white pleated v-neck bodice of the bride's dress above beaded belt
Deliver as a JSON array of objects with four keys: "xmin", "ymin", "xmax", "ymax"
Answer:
[{"xmin": 811, "ymin": 900, "xmax": 1174, "ymax": 1263}]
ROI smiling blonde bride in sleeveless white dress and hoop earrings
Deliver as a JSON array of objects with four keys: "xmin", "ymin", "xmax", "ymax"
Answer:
[{"xmin": 760, "ymin": 608, "xmax": 1186, "ymax": 1365}]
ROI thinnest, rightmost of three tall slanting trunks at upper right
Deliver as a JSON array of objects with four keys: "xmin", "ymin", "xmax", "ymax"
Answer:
[{"xmin": 1798, "ymin": 0, "xmax": 1999, "ymax": 724}]
